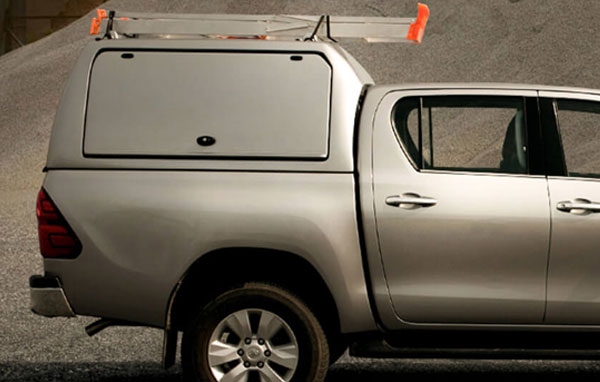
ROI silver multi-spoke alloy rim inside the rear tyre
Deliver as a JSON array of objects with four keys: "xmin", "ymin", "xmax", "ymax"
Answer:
[{"xmin": 208, "ymin": 309, "xmax": 298, "ymax": 382}]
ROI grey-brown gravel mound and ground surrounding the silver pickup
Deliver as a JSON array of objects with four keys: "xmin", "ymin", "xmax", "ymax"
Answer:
[{"xmin": 0, "ymin": 0, "xmax": 600, "ymax": 381}]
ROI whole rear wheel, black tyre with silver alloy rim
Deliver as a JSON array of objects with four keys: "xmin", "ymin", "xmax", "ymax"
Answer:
[{"xmin": 181, "ymin": 283, "xmax": 329, "ymax": 382}]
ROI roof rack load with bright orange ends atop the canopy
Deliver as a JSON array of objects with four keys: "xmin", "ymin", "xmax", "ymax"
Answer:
[{"xmin": 90, "ymin": 4, "xmax": 429, "ymax": 44}]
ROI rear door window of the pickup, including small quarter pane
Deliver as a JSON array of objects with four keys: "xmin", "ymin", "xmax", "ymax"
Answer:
[{"xmin": 393, "ymin": 96, "xmax": 527, "ymax": 174}]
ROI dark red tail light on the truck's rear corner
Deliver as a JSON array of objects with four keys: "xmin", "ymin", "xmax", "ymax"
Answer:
[{"xmin": 36, "ymin": 188, "xmax": 81, "ymax": 259}]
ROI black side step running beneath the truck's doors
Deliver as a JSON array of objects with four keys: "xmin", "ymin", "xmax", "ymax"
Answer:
[{"xmin": 350, "ymin": 332, "xmax": 600, "ymax": 360}]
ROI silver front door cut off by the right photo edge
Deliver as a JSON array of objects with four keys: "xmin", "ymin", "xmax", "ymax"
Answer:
[{"xmin": 540, "ymin": 92, "xmax": 600, "ymax": 325}]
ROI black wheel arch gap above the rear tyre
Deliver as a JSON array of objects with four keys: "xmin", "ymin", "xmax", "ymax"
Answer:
[{"xmin": 166, "ymin": 247, "xmax": 340, "ymax": 341}]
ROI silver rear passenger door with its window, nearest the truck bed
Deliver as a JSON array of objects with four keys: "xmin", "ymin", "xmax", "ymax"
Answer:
[{"xmin": 373, "ymin": 89, "xmax": 550, "ymax": 328}]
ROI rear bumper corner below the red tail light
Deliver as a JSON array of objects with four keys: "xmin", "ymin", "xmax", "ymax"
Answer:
[{"xmin": 29, "ymin": 275, "xmax": 75, "ymax": 317}]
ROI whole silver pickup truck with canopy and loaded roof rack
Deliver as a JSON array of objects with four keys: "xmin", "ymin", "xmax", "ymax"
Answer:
[{"xmin": 30, "ymin": 7, "xmax": 600, "ymax": 381}]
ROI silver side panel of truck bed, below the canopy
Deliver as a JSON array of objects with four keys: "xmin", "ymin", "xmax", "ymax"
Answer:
[{"xmin": 44, "ymin": 170, "xmax": 374, "ymax": 331}]
